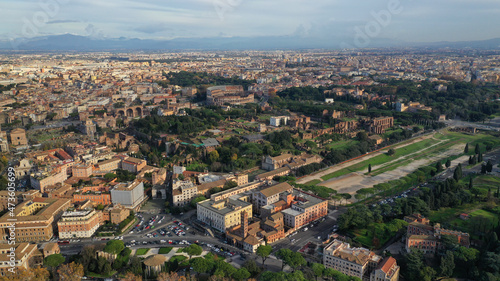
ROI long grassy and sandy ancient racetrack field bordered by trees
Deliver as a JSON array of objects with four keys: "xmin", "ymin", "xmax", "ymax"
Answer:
[{"xmin": 298, "ymin": 130, "xmax": 500, "ymax": 199}]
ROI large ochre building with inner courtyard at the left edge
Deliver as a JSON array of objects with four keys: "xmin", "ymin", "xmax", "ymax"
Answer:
[{"xmin": 0, "ymin": 197, "xmax": 72, "ymax": 242}]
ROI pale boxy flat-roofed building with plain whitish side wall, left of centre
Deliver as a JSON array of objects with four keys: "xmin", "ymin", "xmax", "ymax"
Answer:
[{"xmin": 111, "ymin": 181, "xmax": 145, "ymax": 210}]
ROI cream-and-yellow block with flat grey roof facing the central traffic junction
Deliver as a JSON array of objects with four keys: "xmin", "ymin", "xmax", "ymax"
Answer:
[{"xmin": 197, "ymin": 195, "xmax": 252, "ymax": 233}]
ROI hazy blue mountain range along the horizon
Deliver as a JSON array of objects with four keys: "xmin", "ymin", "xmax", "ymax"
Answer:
[{"xmin": 0, "ymin": 34, "xmax": 500, "ymax": 51}]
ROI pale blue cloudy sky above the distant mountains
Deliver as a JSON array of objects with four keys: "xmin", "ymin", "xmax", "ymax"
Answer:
[{"xmin": 0, "ymin": 0, "xmax": 500, "ymax": 44}]
